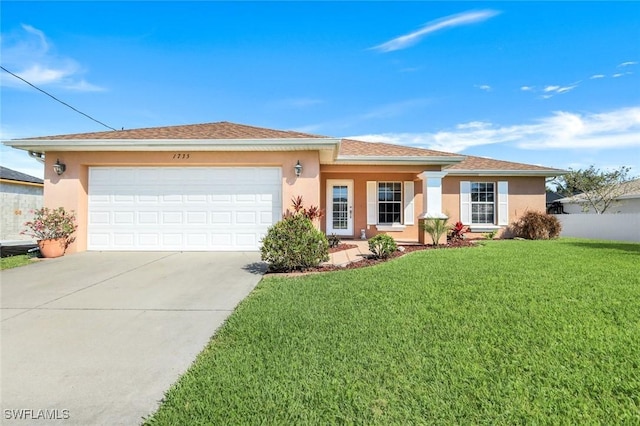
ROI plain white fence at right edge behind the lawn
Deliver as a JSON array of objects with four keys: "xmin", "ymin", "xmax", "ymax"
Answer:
[{"xmin": 555, "ymin": 213, "xmax": 640, "ymax": 242}]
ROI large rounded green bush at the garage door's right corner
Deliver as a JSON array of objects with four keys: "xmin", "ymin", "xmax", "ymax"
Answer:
[{"xmin": 260, "ymin": 213, "xmax": 329, "ymax": 272}]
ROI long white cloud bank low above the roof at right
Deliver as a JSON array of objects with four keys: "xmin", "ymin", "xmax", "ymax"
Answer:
[{"xmin": 350, "ymin": 106, "xmax": 640, "ymax": 152}]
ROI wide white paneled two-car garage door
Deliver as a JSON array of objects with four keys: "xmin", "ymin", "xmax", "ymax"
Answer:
[{"xmin": 87, "ymin": 167, "xmax": 282, "ymax": 251}]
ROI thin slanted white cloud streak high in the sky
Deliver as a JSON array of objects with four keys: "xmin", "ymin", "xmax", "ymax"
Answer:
[{"xmin": 372, "ymin": 10, "xmax": 500, "ymax": 52}]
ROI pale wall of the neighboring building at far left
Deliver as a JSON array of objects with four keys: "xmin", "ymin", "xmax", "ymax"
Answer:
[{"xmin": 0, "ymin": 182, "xmax": 43, "ymax": 241}]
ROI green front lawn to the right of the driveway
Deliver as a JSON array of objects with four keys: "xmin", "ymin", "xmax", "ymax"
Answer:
[{"xmin": 148, "ymin": 239, "xmax": 640, "ymax": 425}]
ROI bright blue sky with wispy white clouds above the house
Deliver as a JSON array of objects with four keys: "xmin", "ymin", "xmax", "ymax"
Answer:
[{"xmin": 0, "ymin": 1, "xmax": 640, "ymax": 180}]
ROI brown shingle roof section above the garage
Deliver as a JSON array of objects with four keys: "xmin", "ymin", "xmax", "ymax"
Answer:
[{"xmin": 25, "ymin": 121, "xmax": 324, "ymax": 140}]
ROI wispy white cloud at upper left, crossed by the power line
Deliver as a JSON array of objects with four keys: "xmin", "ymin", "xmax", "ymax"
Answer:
[{"xmin": 0, "ymin": 24, "xmax": 104, "ymax": 92}]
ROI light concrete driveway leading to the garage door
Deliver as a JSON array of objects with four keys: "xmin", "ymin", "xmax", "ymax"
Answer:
[{"xmin": 0, "ymin": 252, "xmax": 264, "ymax": 425}]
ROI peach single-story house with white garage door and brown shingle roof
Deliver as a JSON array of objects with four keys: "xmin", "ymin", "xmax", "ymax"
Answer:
[{"xmin": 5, "ymin": 122, "xmax": 564, "ymax": 251}]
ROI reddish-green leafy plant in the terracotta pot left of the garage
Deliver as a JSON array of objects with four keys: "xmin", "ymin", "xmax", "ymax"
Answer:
[{"xmin": 21, "ymin": 207, "xmax": 78, "ymax": 247}]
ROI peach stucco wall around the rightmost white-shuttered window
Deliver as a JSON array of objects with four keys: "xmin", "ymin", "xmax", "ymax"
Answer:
[{"xmin": 442, "ymin": 176, "xmax": 546, "ymax": 233}]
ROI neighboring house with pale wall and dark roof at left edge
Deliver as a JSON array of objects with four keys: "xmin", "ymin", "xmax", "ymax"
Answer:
[{"xmin": 0, "ymin": 166, "xmax": 44, "ymax": 241}]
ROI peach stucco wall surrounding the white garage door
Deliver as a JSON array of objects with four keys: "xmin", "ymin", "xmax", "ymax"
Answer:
[{"xmin": 44, "ymin": 151, "xmax": 320, "ymax": 253}]
